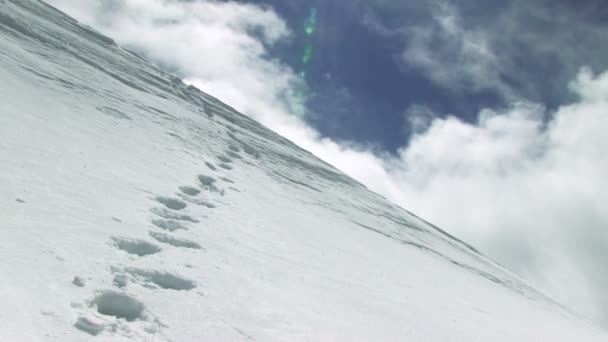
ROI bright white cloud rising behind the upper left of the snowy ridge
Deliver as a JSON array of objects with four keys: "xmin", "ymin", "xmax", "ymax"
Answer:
[{"xmin": 50, "ymin": 0, "xmax": 302, "ymax": 119}]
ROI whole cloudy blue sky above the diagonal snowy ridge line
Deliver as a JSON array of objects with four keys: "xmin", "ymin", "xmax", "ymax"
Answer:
[{"xmin": 49, "ymin": 0, "xmax": 608, "ymax": 327}]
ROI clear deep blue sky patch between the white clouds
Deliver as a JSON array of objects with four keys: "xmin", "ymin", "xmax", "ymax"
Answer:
[{"xmin": 260, "ymin": 1, "xmax": 460, "ymax": 151}]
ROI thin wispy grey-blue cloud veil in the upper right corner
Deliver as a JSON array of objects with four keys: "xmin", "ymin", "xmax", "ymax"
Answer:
[{"xmin": 364, "ymin": 0, "xmax": 608, "ymax": 108}]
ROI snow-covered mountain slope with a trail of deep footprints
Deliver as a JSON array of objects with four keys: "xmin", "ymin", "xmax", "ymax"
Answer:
[{"xmin": 0, "ymin": 0, "xmax": 608, "ymax": 341}]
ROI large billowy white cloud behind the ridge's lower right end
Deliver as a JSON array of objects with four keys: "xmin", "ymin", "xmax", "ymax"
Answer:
[{"xmin": 389, "ymin": 69, "xmax": 608, "ymax": 320}]
